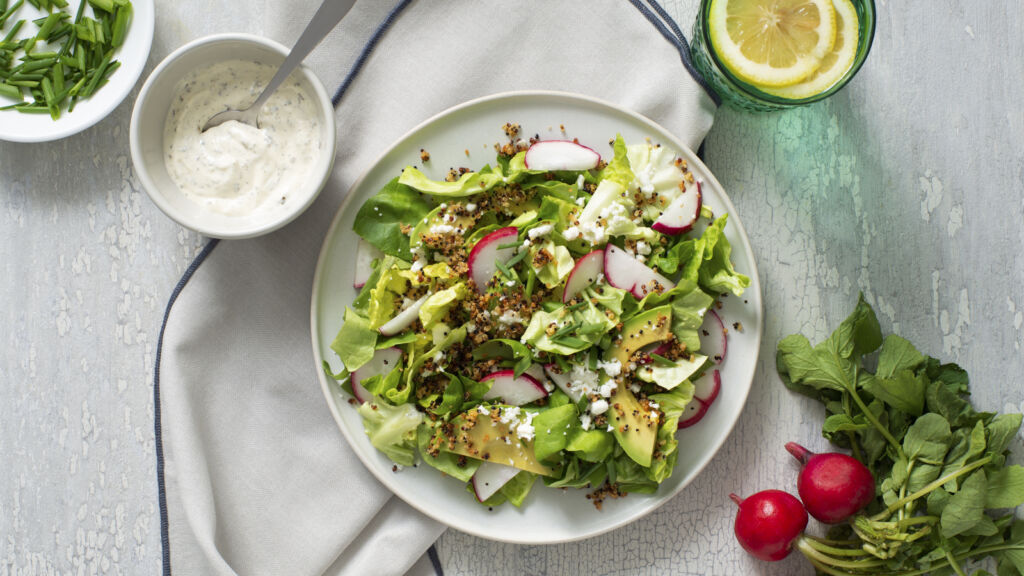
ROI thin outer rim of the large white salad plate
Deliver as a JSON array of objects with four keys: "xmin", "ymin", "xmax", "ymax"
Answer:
[{"xmin": 309, "ymin": 90, "xmax": 764, "ymax": 545}]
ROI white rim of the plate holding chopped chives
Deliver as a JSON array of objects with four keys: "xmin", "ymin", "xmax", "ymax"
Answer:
[{"xmin": 0, "ymin": 0, "xmax": 157, "ymax": 142}]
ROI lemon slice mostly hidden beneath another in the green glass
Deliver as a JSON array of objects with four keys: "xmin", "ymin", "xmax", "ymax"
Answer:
[{"xmin": 761, "ymin": 0, "xmax": 860, "ymax": 100}]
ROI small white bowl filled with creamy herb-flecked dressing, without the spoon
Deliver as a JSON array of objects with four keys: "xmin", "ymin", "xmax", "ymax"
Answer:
[{"xmin": 129, "ymin": 34, "xmax": 337, "ymax": 239}]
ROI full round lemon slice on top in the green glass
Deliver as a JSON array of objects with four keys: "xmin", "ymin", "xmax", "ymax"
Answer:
[{"xmin": 708, "ymin": 0, "xmax": 836, "ymax": 87}]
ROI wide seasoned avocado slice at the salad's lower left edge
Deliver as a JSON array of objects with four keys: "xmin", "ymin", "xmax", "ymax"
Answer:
[{"xmin": 447, "ymin": 408, "xmax": 555, "ymax": 476}]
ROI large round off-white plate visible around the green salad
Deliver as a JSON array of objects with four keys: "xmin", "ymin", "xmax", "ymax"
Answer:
[{"xmin": 311, "ymin": 92, "xmax": 762, "ymax": 544}]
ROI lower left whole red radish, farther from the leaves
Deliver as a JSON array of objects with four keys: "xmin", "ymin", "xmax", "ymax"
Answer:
[{"xmin": 729, "ymin": 490, "xmax": 807, "ymax": 562}]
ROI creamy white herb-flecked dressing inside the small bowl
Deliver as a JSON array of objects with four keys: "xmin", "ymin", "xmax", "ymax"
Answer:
[{"xmin": 164, "ymin": 60, "xmax": 324, "ymax": 217}]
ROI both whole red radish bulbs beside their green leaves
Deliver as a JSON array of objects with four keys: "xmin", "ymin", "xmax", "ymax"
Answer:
[{"xmin": 729, "ymin": 442, "xmax": 874, "ymax": 562}]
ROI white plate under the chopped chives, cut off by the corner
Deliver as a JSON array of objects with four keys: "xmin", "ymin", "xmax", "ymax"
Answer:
[{"xmin": 0, "ymin": 0, "xmax": 154, "ymax": 142}]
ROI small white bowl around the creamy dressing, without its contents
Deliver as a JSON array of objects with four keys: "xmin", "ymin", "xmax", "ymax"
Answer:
[{"xmin": 129, "ymin": 34, "xmax": 337, "ymax": 239}]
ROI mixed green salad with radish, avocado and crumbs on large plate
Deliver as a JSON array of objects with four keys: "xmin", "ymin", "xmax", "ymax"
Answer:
[{"xmin": 325, "ymin": 129, "xmax": 750, "ymax": 507}]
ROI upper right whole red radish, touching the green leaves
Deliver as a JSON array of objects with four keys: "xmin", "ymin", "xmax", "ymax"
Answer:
[{"xmin": 785, "ymin": 442, "xmax": 874, "ymax": 524}]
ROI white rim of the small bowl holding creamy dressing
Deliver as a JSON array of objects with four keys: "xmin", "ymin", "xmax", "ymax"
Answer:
[{"xmin": 128, "ymin": 33, "xmax": 338, "ymax": 240}]
